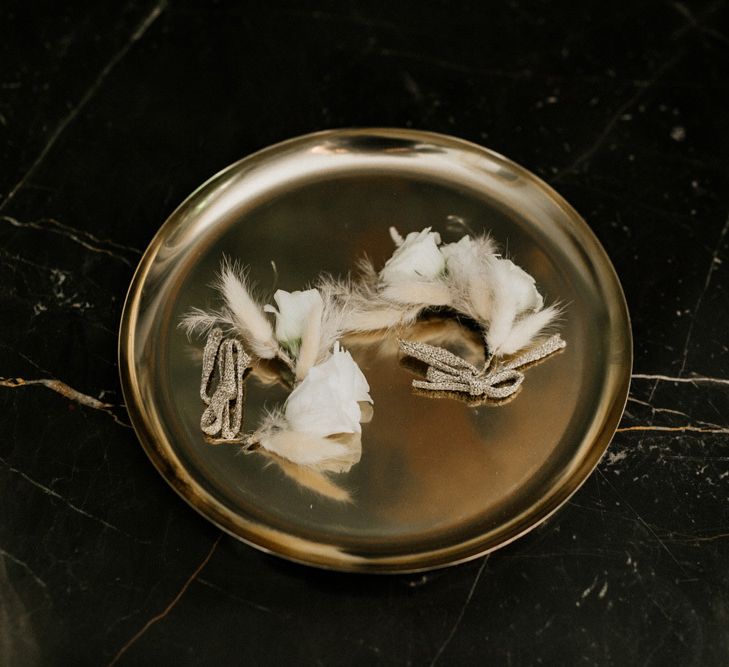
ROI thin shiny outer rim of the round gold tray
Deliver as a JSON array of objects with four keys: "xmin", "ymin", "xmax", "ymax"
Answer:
[{"xmin": 117, "ymin": 127, "xmax": 633, "ymax": 574}]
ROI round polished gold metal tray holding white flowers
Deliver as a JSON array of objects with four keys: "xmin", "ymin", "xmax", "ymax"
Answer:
[{"xmin": 119, "ymin": 129, "xmax": 632, "ymax": 572}]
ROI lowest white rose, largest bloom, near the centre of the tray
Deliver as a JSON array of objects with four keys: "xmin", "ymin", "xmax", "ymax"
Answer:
[{"xmin": 284, "ymin": 343, "xmax": 372, "ymax": 437}]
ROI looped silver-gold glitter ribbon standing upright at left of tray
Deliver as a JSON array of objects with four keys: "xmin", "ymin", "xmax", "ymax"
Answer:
[{"xmin": 200, "ymin": 327, "xmax": 251, "ymax": 440}]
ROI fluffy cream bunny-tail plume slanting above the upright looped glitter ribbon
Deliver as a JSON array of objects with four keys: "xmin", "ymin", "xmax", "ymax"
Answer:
[{"xmin": 218, "ymin": 261, "xmax": 280, "ymax": 359}]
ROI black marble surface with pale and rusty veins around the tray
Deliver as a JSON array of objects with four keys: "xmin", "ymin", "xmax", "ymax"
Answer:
[{"xmin": 0, "ymin": 0, "xmax": 729, "ymax": 665}]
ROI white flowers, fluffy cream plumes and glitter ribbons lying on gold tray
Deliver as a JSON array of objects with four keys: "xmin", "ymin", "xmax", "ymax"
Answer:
[{"xmin": 181, "ymin": 228, "xmax": 565, "ymax": 472}]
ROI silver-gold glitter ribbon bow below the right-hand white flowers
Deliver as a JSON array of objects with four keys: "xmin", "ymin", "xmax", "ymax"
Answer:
[{"xmin": 399, "ymin": 334, "xmax": 567, "ymax": 400}]
